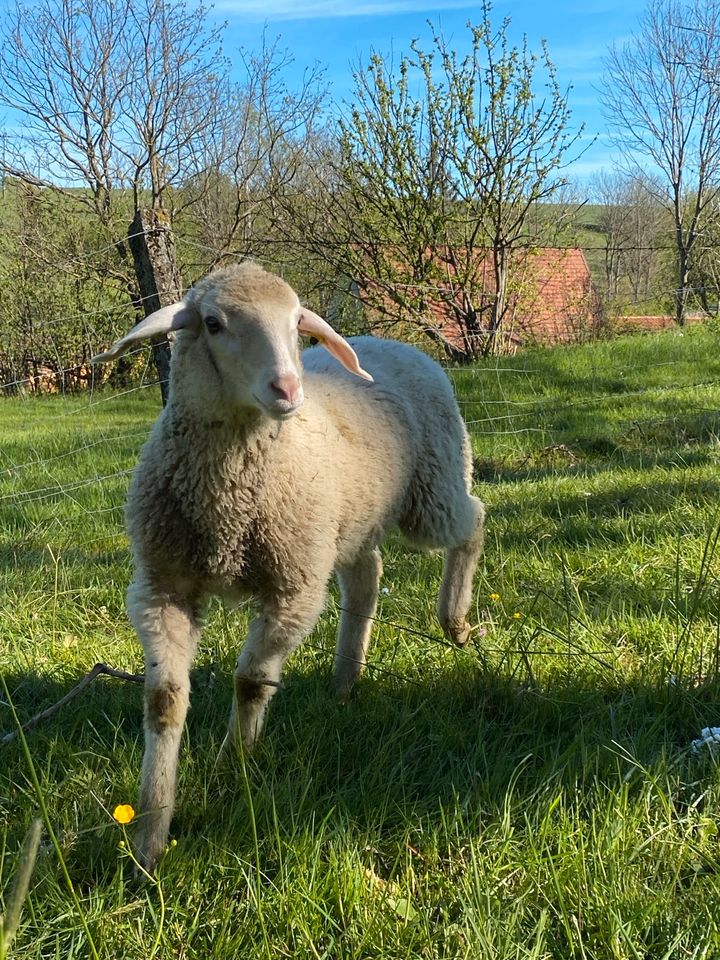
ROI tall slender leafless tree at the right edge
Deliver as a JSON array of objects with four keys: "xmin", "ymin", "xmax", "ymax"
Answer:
[{"xmin": 603, "ymin": 0, "xmax": 720, "ymax": 324}]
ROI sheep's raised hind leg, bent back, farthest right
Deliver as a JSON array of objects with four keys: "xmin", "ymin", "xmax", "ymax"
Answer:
[{"xmin": 438, "ymin": 497, "xmax": 485, "ymax": 647}]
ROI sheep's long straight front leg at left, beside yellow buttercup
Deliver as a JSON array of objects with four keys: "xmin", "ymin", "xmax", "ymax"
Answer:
[{"xmin": 128, "ymin": 587, "xmax": 199, "ymax": 870}]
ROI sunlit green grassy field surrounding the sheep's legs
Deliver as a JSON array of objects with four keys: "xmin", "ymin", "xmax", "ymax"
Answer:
[{"xmin": 0, "ymin": 329, "xmax": 720, "ymax": 960}]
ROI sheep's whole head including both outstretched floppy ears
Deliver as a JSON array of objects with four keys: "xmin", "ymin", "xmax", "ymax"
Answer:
[{"xmin": 93, "ymin": 261, "xmax": 372, "ymax": 420}]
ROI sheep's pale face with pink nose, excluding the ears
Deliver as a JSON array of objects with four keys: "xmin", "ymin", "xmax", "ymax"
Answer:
[{"xmin": 194, "ymin": 274, "xmax": 304, "ymax": 420}]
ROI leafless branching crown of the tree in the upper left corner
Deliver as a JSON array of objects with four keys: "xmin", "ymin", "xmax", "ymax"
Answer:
[{"xmin": 0, "ymin": 0, "xmax": 226, "ymax": 224}]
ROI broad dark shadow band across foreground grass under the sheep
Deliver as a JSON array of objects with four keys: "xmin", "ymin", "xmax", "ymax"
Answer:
[{"xmin": 0, "ymin": 657, "xmax": 720, "ymax": 886}]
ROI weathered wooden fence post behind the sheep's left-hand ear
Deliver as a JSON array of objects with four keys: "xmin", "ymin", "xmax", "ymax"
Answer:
[{"xmin": 128, "ymin": 210, "xmax": 182, "ymax": 406}]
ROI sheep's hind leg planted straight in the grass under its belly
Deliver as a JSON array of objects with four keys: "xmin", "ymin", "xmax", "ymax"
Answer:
[{"xmin": 333, "ymin": 549, "xmax": 382, "ymax": 698}]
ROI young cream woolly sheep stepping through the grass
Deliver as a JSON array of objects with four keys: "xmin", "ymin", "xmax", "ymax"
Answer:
[{"xmin": 93, "ymin": 260, "xmax": 485, "ymax": 870}]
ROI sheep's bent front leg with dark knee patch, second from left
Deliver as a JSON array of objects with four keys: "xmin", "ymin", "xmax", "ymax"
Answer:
[{"xmin": 223, "ymin": 584, "xmax": 325, "ymax": 751}]
